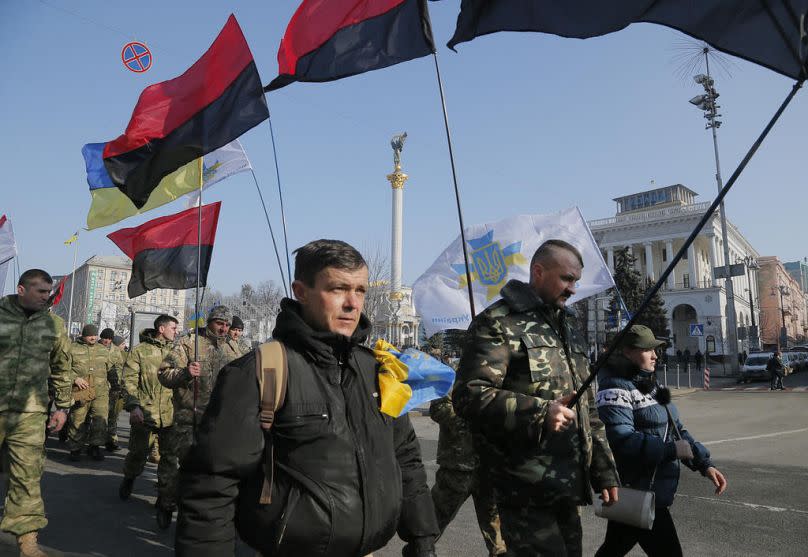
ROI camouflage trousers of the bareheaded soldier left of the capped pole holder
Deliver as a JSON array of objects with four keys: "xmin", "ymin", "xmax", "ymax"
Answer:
[{"xmin": 123, "ymin": 424, "xmax": 178, "ymax": 508}]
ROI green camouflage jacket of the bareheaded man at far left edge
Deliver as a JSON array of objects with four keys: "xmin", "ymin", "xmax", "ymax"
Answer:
[{"xmin": 0, "ymin": 294, "xmax": 73, "ymax": 412}]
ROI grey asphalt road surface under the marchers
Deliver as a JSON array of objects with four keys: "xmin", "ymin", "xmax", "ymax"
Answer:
[{"xmin": 0, "ymin": 382, "xmax": 808, "ymax": 557}]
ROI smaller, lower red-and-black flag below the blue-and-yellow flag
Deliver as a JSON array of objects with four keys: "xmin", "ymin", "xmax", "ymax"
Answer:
[{"xmin": 107, "ymin": 202, "xmax": 221, "ymax": 298}]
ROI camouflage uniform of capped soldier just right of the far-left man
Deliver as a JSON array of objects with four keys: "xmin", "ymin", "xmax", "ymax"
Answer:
[{"xmin": 67, "ymin": 337, "xmax": 113, "ymax": 452}]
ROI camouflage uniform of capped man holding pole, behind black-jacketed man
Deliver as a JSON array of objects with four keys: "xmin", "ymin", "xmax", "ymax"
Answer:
[{"xmin": 157, "ymin": 328, "xmax": 240, "ymax": 508}]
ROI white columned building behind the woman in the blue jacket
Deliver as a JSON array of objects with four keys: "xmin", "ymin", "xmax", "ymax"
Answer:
[{"xmin": 589, "ymin": 184, "xmax": 759, "ymax": 354}]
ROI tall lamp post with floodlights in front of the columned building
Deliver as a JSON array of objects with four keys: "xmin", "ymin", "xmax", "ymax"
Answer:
[{"xmin": 690, "ymin": 51, "xmax": 738, "ymax": 370}]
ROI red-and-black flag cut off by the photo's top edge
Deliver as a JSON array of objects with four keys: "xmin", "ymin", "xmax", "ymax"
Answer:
[{"xmin": 265, "ymin": 0, "xmax": 435, "ymax": 91}]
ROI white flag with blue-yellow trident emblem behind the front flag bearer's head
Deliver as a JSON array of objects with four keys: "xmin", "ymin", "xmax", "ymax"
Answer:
[{"xmin": 413, "ymin": 207, "xmax": 614, "ymax": 336}]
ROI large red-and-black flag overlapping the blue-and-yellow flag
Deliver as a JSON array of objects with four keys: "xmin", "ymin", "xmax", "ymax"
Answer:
[{"xmin": 103, "ymin": 15, "xmax": 269, "ymax": 209}]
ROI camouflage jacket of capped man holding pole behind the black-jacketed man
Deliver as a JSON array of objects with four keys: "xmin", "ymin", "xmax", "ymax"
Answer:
[{"xmin": 158, "ymin": 328, "xmax": 241, "ymax": 425}]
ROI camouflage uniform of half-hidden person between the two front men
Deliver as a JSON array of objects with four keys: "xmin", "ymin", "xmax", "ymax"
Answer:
[{"xmin": 429, "ymin": 396, "xmax": 505, "ymax": 555}]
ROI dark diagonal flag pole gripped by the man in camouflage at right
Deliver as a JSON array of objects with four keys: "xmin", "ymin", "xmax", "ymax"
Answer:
[{"xmin": 567, "ymin": 79, "xmax": 804, "ymax": 408}]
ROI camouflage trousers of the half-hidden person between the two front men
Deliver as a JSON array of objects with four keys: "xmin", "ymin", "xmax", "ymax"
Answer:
[{"xmin": 432, "ymin": 466, "xmax": 505, "ymax": 555}]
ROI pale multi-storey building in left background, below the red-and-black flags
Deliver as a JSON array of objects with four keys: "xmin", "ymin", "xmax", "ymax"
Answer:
[{"xmin": 54, "ymin": 255, "xmax": 186, "ymax": 340}]
